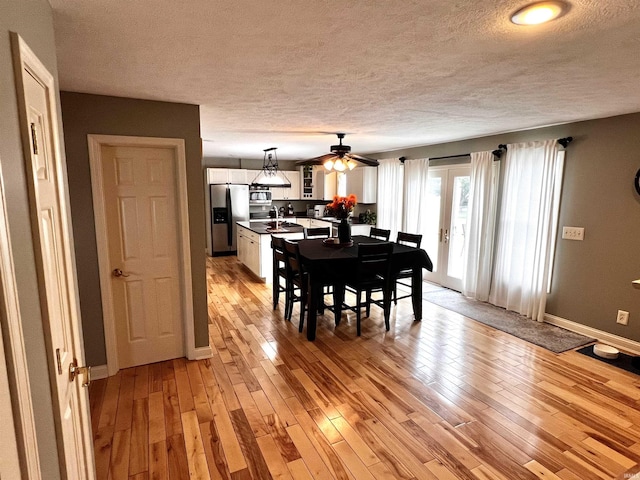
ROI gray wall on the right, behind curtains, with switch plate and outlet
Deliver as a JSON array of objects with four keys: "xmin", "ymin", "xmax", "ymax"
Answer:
[{"xmin": 376, "ymin": 113, "xmax": 640, "ymax": 341}]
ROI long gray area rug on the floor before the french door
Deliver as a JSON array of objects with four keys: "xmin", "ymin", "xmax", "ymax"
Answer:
[{"xmin": 422, "ymin": 283, "xmax": 595, "ymax": 353}]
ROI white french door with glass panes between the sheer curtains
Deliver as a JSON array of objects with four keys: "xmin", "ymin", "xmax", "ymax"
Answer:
[{"xmin": 423, "ymin": 165, "xmax": 471, "ymax": 291}]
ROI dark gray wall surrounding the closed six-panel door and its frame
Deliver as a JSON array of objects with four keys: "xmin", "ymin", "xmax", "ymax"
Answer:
[{"xmin": 61, "ymin": 92, "xmax": 209, "ymax": 365}]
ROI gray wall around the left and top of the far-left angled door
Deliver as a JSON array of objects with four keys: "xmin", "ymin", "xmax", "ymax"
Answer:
[{"xmin": 0, "ymin": 0, "xmax": 62, "ymax": 479}]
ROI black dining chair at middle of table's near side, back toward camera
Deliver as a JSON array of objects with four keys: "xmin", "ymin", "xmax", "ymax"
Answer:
[{"xmin": 343, "ymin": 242, "xmax": 393, "ymax": 336}]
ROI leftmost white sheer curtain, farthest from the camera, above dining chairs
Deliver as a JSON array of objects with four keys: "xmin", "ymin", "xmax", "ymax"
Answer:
[{"xmin": 376, "ymin": 158, "xmax": 404, "ymax": 239}]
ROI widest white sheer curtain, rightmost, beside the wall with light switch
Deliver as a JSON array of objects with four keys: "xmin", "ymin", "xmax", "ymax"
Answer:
[{"xmin": 489, "ymin": 140, "xmax": 562, "ymax": 321}]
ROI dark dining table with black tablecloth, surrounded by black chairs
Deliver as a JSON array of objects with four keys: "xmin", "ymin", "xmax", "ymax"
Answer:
[{"xmin": 298, "ymin": 236, "xmax": 433, "ymax": 340}]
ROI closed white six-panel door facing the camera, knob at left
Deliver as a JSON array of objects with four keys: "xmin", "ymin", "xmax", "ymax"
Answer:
[{"xmin": 102, "ymin": 145, "xmax": 185, "ymax": 368}]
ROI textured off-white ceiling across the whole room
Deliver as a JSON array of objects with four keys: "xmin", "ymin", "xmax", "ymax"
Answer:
[{"xmin": 50, "ymin": 0, "xmax": 640, "ymax": 159}]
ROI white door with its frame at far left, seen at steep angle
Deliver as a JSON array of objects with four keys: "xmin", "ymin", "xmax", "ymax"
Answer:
[{"xmin": 12, "ymin": 35, "xmax": 95, "ymax": 479}]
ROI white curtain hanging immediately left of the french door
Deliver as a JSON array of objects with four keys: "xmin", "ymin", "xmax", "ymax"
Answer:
[{"xmin": 402, "ymin": 158, "xmax": 429, "ymax": 238}]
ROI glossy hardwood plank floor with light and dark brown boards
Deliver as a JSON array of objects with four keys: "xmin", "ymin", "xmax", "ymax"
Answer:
[{"xmin": 89, "ymin": 257, "xmax": 640, "ymax": 480}]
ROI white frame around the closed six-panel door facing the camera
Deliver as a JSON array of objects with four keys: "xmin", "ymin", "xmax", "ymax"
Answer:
[{"xmin": 87, "ymin": 134, "xmax": 197, "ymax": 376}]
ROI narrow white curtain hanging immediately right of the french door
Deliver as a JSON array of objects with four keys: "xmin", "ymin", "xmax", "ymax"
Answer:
[{"xmin": 462, "ymin": 152, "xmax": 500, "ymax": 302}]
